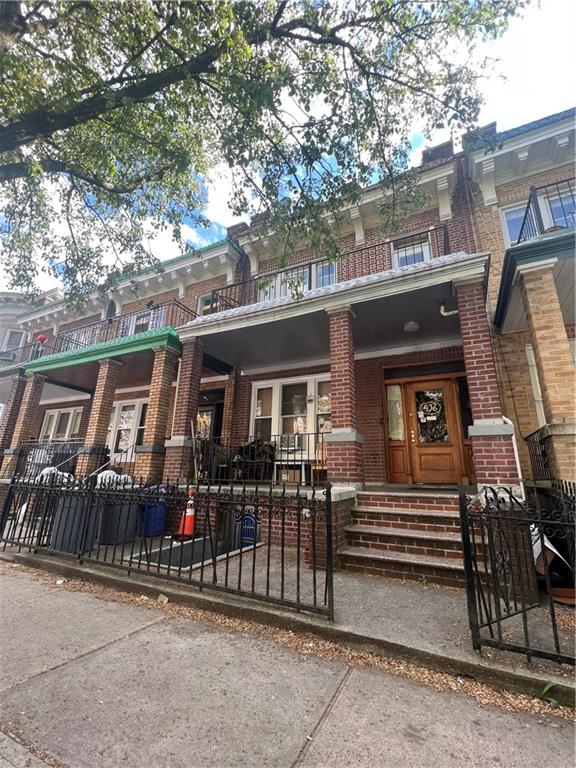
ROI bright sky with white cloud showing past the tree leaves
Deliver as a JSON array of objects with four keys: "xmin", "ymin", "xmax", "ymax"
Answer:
[{"xmin": 0, "ymin": 0, "xmax": 576, "ymax": 287}]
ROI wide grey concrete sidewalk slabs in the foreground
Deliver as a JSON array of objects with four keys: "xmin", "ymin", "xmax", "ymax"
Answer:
[{"xmin": 0, "ymin": 567, "xmax": 574, "ymax": 768}]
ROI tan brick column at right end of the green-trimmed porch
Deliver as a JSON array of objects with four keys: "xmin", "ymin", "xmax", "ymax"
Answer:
[{"xmin": 134, "ymin": 347, "xmax": 178, "ymax": 479}]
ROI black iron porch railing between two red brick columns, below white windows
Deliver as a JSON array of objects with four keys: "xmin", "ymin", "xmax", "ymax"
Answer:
[{"xmin": 194, "ymin": 433, "xmax": 327, "ymax": 486}]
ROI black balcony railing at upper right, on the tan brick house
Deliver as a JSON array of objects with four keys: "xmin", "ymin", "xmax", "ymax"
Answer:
[{"xmin": 517, "ymin": 179, "xmax": 576, "ymax": 243}]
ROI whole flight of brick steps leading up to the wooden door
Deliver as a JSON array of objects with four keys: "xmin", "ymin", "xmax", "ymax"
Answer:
[{"xmin": 338, "ymin": 490, "xmax": 465, "ymax": 587}]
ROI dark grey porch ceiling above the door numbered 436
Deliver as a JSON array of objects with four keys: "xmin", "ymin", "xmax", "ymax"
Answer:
[{"xmin": 196, "ymin": 281, "xmax": 460, "ymax": 370}]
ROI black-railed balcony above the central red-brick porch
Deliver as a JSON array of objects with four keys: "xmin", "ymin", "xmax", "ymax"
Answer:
[{"xmin": 207, "ymin": 225, "xmax": 450, "ymax": 315}]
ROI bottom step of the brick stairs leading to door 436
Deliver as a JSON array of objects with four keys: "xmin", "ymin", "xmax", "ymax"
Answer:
[{"xmin": 338, "ymin": 546, "xmax": 465, "ymax": 587}]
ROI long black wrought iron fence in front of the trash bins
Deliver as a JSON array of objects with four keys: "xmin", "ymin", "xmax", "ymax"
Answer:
[{"xmin": 0, "ymin": 474, "xmax": 334, "ymax": 618}]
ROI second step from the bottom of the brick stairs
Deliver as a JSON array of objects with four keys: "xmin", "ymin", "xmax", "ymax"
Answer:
[{"xmin": 345, "ymin": 525, "xmax": 462, "ymax": 559}]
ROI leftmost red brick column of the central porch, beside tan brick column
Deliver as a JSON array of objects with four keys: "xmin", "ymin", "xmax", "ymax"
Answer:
[{"xmin": 164, "ymin": 339, "xmax": 203, "ymax": 480}]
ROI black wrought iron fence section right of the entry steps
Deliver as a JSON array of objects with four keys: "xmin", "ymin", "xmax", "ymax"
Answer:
[{"xmin": 460, "ymin": 488, "xmax": 576, "ymax": 664}]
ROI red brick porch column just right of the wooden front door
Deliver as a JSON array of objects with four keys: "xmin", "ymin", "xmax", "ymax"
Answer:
[{"xmin": 454, "ymin": 279, "xmax": 520, "ymax": 488}]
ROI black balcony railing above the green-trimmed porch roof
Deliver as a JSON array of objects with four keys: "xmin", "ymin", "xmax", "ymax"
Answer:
[{"xmin": 54, "ymin": 300, "xmax": 196, "ymax": 352}]
